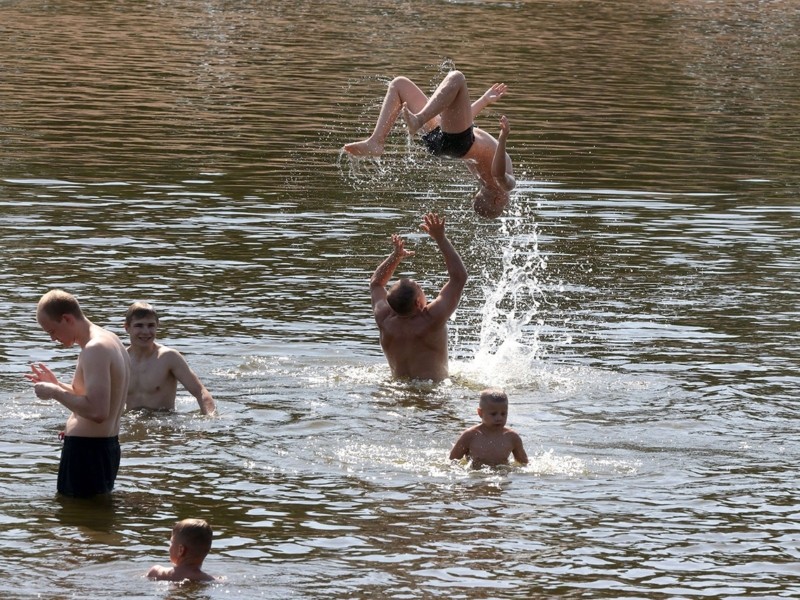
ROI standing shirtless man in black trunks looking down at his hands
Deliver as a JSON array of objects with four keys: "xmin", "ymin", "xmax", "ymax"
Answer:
[{"xmin": 26, "ymin": 290, "xmax": 131, "ymax": 497}]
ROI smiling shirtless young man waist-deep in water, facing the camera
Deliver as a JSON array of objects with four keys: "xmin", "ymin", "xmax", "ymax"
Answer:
[{"xmin": 125, "ymin": 302, "xmax": 217, "ymax": 415}]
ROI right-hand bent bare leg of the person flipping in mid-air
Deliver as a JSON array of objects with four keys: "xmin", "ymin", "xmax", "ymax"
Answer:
[{"xmin": 403, "ymin": 71, "xmax": 472, "ymax": 135}]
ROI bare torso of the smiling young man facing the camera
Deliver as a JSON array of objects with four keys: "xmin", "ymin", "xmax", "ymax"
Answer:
[{"xmin": 127, "ymin": 344, "xmax": 178, "ymax": 410}]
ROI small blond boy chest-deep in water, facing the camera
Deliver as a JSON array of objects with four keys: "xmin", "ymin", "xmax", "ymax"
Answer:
[{"xmin": 450, "ymin": 388, "xmax": 528, "ymax": 468}]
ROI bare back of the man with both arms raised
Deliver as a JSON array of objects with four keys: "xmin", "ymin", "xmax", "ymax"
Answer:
[{"xmin": 379, "ymin": 309, "xmax": 448, "ymax": 381}]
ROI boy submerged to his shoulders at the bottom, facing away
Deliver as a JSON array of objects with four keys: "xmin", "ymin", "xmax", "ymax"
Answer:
[{"xmin": 147, "ymin": 519, "xmax": 216, "ymax": 581}]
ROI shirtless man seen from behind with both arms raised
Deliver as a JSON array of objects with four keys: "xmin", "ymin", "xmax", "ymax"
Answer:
[{"xmin": 370, "ymin": 213, "xmax": 467, "ymax": 382}]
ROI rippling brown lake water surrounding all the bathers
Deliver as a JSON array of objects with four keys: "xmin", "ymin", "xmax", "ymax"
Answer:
[{"xmin": 0, "ymin": 0, "xmax": 800, "ymax": 599}]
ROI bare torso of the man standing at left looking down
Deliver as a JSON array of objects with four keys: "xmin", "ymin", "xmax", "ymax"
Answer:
[{"xmin": 64, "ymin": 325, "xmax": 130, "ymax": 437}]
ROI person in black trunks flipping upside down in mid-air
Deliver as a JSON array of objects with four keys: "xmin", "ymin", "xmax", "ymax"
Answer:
[{"xmin": 344, "ymin": 71, "xmax": 516, "ymax": 219}]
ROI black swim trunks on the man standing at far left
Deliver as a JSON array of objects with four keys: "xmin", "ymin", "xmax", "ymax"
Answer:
[{"xmin": 58, "ymin": 435, "xmax": 121, "ymax": 498}]
